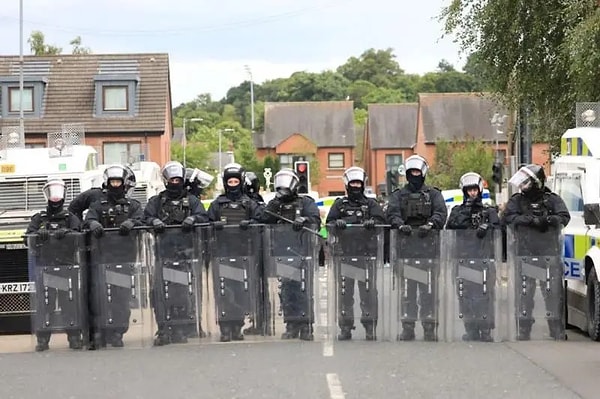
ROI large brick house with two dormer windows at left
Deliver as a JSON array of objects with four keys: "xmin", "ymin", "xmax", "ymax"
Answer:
[{"xmin": 0, "ymin": 54, "xmax": 173, "ymax": 165}]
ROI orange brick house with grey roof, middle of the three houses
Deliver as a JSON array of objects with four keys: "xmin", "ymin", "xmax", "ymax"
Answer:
[{"xmin": 254, "ymin": 101, "xmax": 356, "ymax": 196}]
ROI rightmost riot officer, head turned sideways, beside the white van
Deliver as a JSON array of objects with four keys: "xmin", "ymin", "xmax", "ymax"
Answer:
[{"xmin": 502, "ymin": 164, "xmax": 571, "ymax": 340}]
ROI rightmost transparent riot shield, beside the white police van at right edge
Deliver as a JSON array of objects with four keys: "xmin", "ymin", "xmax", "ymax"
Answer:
[{"xmin": 506, "ymin": 226, "xmax": 565, "ymax": 341}]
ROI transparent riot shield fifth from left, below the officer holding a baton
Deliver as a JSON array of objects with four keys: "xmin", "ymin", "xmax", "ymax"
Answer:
[{"xmin": 264, "ymin": 224, "xmax": 322, "ymax": 341}]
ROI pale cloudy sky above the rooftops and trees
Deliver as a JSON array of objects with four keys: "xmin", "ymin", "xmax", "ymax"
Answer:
[{"xmin": 0, "ymin": 0, "xmax": 465, "ymax": 106}]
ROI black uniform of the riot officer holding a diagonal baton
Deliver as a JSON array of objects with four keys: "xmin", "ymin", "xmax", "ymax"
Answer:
[{"xmin": 263, "ymin": 194, "xmax": 321, "ymax": 340}]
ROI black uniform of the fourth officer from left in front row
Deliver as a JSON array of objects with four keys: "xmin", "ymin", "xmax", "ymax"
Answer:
[{"xmin": 208, "ymin": 193, "xmax": 262, "ymax": 342}]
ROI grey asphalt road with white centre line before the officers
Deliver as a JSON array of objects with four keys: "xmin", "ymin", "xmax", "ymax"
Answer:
[{"xmin": 0, "ymin": 331, "xmax": 600, "ymax": 399}]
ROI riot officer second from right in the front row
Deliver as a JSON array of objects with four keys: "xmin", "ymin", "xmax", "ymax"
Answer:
[{"xmin": 446, "ymin": 172, "xmax": 500, "ymax": 342}]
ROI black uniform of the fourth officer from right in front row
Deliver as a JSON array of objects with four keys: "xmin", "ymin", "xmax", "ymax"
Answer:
[{"xmin": 325, "ymin": 194, "xmax": 385, "ymax": 339}]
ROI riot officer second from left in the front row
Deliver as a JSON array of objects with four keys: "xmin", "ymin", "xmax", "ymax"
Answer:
[{"xmin": 84, "ymin": 165, "xmax": 144, "ymax": 347}]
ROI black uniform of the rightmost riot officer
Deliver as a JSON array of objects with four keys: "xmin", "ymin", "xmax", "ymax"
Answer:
[{"xmin": 502, "ymin": 187, "xmax": 571, "ymax": 340}]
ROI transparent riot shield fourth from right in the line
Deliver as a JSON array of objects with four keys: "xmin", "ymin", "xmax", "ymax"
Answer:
[{"xmin": 328, "ymin": 225, "xmax": 395, "ymax": 341}]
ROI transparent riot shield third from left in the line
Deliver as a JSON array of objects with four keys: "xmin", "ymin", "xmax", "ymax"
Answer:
[{"xmin": 150, "ymin": 226, "xmax": 204, "ymax": 346}]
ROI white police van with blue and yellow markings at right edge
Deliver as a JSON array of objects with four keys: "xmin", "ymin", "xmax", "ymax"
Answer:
[{"xmin": 550, "ymin": 127, "xmax": 600, "ymax": 341}]
